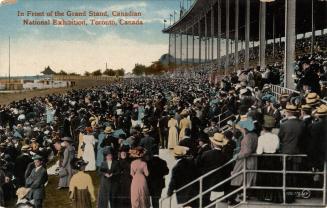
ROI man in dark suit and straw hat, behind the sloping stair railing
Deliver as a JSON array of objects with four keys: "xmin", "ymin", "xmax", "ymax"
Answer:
[{"xmin": 197, "ymin": 133, "xmax": 227, "ymax": 206}]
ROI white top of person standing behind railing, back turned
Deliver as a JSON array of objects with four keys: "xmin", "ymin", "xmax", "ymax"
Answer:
[{"xmin": 257, "ymin": 132, "xmax": 279, "ymax": 154}]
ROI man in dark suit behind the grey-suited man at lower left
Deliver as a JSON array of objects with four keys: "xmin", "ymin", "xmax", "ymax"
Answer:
[{"xmin": 14, "ymin": 145, "xmax": 33, "ymax": 188}]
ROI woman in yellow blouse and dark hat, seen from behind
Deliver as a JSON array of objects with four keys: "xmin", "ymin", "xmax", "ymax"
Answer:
[{"xmin": 69, "ymin": 158, "xmax": 95, "ymax": 208}]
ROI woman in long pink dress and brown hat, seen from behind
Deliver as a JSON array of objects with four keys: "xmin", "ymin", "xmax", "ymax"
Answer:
[{"xmin": 130, "ymin": 148, "xmax": 150, "ymax": 208}]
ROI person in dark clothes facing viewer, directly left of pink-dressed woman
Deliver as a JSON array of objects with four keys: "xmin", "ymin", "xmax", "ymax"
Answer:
[{"xmin": 98, "ymin": 147, "xmax": 120, "ymax": 208}]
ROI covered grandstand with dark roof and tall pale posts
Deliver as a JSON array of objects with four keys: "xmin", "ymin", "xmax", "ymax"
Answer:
[{"xmin": 163, "ymin": 0, "xmax": 327, "ymax": 88}]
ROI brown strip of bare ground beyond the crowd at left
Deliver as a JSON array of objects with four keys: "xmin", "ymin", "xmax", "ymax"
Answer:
[{"xmin": 0, "ymin": 80, "xmax": 114, "ymax": 105}]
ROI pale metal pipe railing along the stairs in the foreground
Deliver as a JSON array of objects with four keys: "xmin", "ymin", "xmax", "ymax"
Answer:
[{"xmin": 160, "ymin": 154, "xmax": 327, "ymax": 208}]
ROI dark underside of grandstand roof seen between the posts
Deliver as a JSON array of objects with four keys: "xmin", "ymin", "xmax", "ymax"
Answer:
[{"xmin": 163, "ymin": 0, "xmax": 327, "ymax": 40}]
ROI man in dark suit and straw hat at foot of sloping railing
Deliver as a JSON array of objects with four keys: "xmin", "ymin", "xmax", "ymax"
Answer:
[{"xmin": 167, "ymin": 146, "xmax": 199, "ymax": 207}]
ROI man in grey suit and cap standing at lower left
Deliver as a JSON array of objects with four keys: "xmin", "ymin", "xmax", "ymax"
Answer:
[{"xmin": 26, "ymin": 155, "xmax": 48, "ymax": 208}]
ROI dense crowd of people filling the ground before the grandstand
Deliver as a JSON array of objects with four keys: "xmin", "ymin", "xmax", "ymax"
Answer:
[{"xmin": 0, "ymin": 36, "xmax": 327, "ymax": 208}]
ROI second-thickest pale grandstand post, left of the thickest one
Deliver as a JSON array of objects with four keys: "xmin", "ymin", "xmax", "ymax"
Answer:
[{"xmin": 259, "ymin": 2, "xmax": 266, "ymax": 69}]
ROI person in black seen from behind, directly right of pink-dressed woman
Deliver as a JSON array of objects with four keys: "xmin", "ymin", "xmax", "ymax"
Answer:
[{"xmin": 147, "ymin": 155, "xmax": 169, "ymax": 208}]
